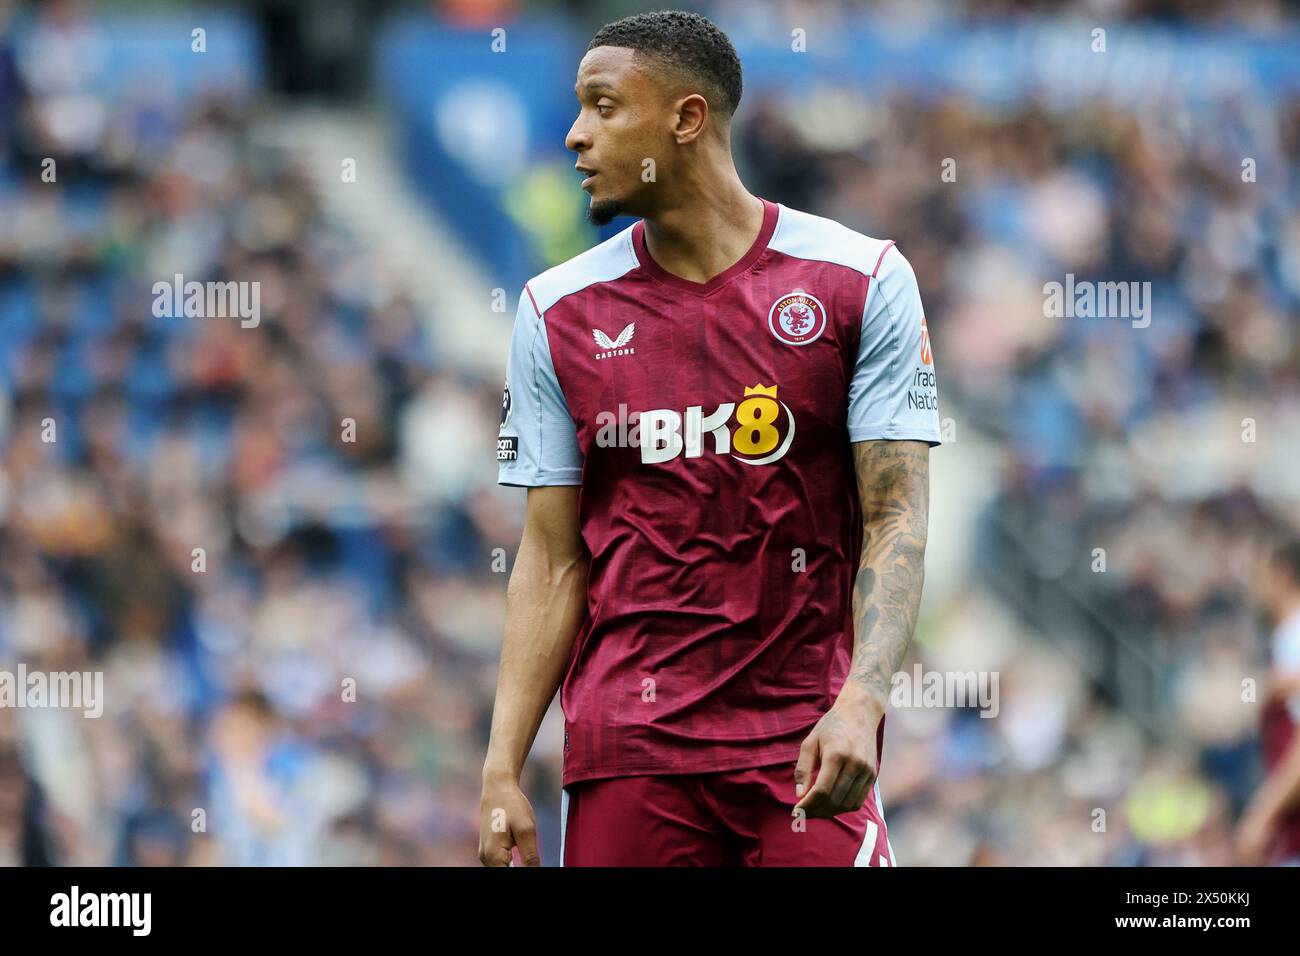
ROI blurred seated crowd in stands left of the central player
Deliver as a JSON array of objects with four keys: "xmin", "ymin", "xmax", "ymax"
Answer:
[{"xmin": 0, "ymin": 0, "xmax": 512, "ymax": 865}]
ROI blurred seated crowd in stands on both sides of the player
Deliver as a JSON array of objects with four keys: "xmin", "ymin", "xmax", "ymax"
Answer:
[{"xmin": 0, "ymin": 5, "xmax": 1300, "ymax": 865}]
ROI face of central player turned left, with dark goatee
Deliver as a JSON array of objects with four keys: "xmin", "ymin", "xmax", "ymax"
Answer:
[{"xmin": 564, "ymin": 47, "xmax": 673, "ymax": 225}]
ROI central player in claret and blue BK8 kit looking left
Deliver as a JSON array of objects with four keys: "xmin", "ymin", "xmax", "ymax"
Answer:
[{"xmin": 480, "ymin": 12, "xmax": 939, "ymax": 866}]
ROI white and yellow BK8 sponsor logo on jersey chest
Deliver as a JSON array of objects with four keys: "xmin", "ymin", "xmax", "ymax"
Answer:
[{"xmin": 595, "ymin": 385, "xmax": 794, "ymax": 464}]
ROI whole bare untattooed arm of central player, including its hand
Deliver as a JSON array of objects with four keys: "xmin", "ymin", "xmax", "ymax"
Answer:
[{"xmin": 478, "ymin": 485, "xmax": 588, "ymax": 866}]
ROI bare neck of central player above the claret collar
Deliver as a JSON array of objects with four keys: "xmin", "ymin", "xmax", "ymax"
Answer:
[{"xmin": 645, "ymin": 152, "xmax": 763, "ymax": 282}]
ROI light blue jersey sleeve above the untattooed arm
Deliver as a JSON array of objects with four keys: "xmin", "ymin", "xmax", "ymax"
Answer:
[{"xmin": 497, "ymin": 286, "xmax": 582, "ymax": 488}]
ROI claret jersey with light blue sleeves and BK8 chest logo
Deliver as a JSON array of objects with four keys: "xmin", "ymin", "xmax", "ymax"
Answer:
[{"xmin": 497, "ymin": 202, "xmax": 939, "ymax": 784}]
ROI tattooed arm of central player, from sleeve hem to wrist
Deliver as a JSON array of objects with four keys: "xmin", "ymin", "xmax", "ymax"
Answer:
[{"xmin": 849, "ymin": 441, "xmax": 930, "ymax": 704}]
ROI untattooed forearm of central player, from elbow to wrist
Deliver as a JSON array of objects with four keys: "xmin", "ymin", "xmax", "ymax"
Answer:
[{"xmin": 484, "ymin": 537, "xmax": 588, "ymax": 779}]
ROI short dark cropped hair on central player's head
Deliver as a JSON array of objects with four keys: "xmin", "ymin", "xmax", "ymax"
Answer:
[{"xmin": 586, "ymin": 10, "xmax": 744, "ymax": 116}]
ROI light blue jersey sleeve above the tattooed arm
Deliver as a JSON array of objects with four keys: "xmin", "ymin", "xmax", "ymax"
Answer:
[{"xmin": 849, "ymin": 246, "xmax": 940, "ymax": 445}]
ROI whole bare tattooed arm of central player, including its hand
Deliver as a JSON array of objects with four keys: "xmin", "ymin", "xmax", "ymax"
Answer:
[{"xmin": 794, "ymin": 441, "xmax": 930, "ymax": 817}]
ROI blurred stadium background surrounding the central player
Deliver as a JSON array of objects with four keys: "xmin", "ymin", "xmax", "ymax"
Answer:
[{"xmin": 0, "ymin": 0, "xmax": 1300, "ymax": 865}]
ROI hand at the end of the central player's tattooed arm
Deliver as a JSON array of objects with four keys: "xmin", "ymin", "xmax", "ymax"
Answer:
[{"xmin": 794, "ymin": 695, "xmax": 884, "ymax": 818}]
